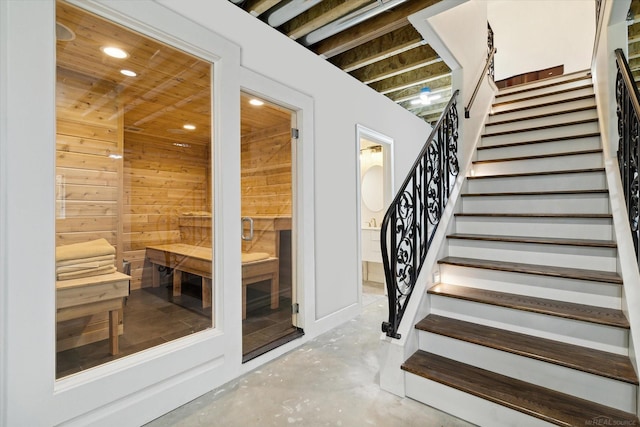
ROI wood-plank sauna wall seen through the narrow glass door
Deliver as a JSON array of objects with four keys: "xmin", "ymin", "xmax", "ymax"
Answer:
[{"xmin": 241, "ymin": 120, "xmax": 292, "ymax": 216}]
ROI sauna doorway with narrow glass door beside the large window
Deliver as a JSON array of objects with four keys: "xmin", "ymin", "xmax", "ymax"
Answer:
[{"xmin": 240, "ymin": 92, "xmax": 303, "ymax": 362}]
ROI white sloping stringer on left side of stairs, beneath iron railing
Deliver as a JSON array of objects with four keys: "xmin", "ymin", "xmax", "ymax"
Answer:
[{"xmin": 379, "ymin": 90, "xmax": 497, "ymax": 397}]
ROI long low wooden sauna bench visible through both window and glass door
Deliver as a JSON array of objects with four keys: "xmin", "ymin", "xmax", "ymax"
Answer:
[{"xmin": 146, "ymin": 243, "xmax": 280, "ymax": 319}]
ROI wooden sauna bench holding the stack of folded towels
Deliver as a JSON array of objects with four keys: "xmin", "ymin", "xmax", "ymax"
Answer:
[{"xmin": 56, "ymin": 272, "xmax": 131, "ymax": 355}]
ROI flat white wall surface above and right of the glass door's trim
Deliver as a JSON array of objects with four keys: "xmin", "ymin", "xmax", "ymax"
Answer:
[{"xmin": 162, "ymin": 0, "xmax": 428, "ymax": 319}]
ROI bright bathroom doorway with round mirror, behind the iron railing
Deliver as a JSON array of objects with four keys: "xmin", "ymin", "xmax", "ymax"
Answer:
[{"xmin": 356, "ymin": 125, "xmax": 393, "ymax": 305}]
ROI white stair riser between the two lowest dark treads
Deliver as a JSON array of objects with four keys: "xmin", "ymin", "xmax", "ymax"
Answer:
[{"xmin": 418, "ymin": 331, "xmax": 635, "ymax": 412}]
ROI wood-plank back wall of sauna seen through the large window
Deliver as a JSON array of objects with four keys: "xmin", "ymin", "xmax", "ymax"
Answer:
[{"xmin": 122, "ymin": 132, "xmax": 212, "ymax": 289}]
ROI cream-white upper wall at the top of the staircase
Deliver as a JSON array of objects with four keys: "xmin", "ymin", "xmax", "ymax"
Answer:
[{"xmin": 487, "ymin": 0, "xmax": 595, "ymax": 80}]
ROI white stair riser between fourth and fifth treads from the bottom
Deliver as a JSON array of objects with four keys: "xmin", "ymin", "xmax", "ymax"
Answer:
[{"xmin": 447, "ymin": 239, "xmax": 617, "ymax": 271}]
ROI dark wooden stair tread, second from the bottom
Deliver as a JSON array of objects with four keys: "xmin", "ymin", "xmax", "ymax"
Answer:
[{"xmin": 415, "ymin": 314, "xmax": 638, "ymax": 385}]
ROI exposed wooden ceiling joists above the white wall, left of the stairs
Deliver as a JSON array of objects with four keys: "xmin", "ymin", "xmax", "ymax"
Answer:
[{"xmin": 229, "ymin": 0, "xmax": 451, "ymax": 123}]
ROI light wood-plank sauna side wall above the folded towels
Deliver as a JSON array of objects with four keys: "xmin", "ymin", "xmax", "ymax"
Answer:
[{"xmin": 56, "ymin": 68, "xmax": 123, "ymax": 267}]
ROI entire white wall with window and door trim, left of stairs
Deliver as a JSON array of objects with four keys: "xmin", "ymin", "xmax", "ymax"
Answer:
[{"xmin": 0, "ymin": 0, "xmax": 429, "ymax": 426}]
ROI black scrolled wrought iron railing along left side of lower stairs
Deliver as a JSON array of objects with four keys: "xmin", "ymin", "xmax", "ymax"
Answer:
[{"xmin": 380, "ymin": 90, "xmax": 459, "ymax": 338}]
